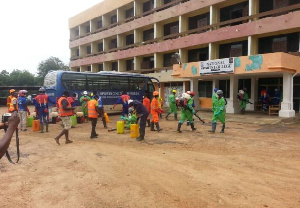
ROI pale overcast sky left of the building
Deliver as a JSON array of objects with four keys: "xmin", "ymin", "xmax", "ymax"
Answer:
[{"xmin": 0, "ymin": 0, "xmax": 103, "ymax": 74}]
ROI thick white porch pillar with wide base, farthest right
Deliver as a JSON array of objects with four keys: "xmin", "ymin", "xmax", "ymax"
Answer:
[{"xmin": 279, "ymin": 73, "xmax": 295, "ymax": 118}]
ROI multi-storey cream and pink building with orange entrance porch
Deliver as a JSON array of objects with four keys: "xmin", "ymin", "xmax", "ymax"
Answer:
[{"xmin": 69, "ymin": 0, "xmax": 300, "ymax": 117}]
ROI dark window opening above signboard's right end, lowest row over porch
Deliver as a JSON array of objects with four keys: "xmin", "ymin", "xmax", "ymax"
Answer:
[{"xmin": 219, "ymin": 40, "xmax": 248, "ymax": 58}]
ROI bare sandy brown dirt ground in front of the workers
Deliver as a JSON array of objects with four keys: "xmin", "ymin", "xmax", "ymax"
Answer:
[{"xmin": 0, "ymin": 108, "xmax": 300, "ymax": 208}]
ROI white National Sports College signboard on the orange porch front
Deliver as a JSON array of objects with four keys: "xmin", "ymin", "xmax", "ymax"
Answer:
[{"xmin": 200, "ymin": 58, "xmax": 234, "ymax": 75}]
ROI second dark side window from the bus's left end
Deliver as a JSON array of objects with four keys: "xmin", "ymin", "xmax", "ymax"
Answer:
[{"xmin": 87, "ymin": 74, "xmax": 109, "ymax": 91}]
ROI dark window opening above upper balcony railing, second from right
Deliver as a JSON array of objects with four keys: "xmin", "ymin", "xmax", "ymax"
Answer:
[{"xmin": 220, "ymin": 1, "xmax": 249, "ymax": 25}]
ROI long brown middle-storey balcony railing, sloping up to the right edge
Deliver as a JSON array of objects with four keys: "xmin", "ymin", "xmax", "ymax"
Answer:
[{"xmin": 70, "ymin": 3, "xmax": 300, "ymax": 61}]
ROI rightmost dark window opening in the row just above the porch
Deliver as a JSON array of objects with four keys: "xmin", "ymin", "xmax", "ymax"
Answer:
[{"xmin": 258, "ymin": 33, "xmax": 299, "ymax": 54}]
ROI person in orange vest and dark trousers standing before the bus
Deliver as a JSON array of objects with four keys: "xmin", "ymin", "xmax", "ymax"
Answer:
[{"xmin": 87, "ymin": 94, "xmax": 100, "ymax": 139}]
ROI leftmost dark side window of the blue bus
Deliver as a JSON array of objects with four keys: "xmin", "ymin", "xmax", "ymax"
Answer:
[{"xmin": 61, "ymin": 73, "xmax": 86, "ymax": 90}]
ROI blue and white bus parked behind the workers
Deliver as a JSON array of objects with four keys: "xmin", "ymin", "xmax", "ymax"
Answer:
[{"xmin": 44, "ymin": 71, "xmax": 160, "ymax": 110}]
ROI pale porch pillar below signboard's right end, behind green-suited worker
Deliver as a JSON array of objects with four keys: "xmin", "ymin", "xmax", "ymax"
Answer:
[{"xmin": 226, "ymin": 75, "xmax": 239, "ymax": 113}]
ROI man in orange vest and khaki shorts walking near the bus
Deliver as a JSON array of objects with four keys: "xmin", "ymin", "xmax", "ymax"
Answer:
[{"xmin": 55, "ymin": 91, "xmax": 75, "ymax": 145}]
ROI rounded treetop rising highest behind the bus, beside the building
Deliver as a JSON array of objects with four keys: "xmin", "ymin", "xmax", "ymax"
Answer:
[{"xmin": 37, "ymin": 56, "xmax": 70, "ymax": 79}]
